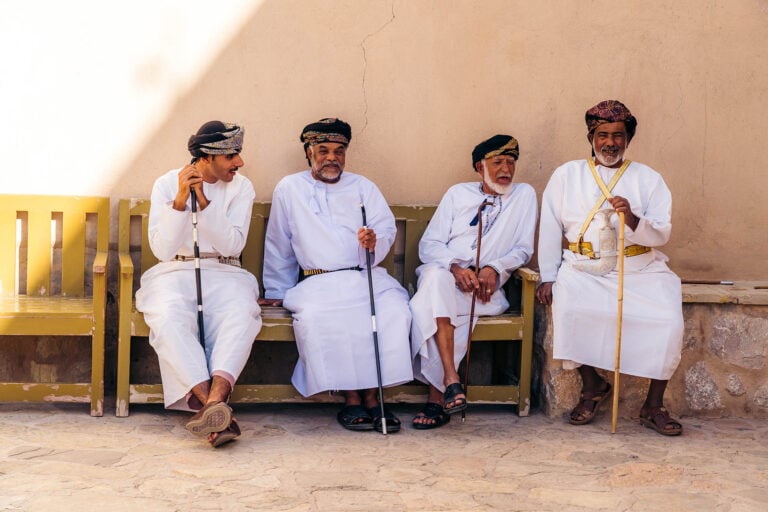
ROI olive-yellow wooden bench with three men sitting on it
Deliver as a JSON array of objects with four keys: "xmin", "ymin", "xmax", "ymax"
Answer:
[{"xmin": 116, "ymin": 199, "xmax": 538, "ymax": 416}]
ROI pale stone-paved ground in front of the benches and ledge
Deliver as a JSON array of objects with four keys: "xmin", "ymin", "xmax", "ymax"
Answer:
[{"xmin": 0, "ymin": 404, "xmax": 768, "ymax": 512}]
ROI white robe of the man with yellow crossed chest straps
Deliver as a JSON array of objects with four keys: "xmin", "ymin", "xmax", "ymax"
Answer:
[{"xmin": 539, "ymin": 160, "xmax": 683, "ymax": 380}]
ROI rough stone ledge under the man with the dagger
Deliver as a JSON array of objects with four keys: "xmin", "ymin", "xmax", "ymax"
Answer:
[{"xmin": 534, "ymin": 281, "xmax": 768, "ymax": 418}]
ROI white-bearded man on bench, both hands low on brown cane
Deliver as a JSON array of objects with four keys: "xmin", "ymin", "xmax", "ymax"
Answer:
[{"xmin": 410, "ymin": 135, "xmax": 537, "ymax": 430}]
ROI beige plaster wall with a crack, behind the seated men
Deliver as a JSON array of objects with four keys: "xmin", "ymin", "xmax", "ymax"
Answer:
[{"xmin": 0, "ymin": 0, "xmax": 768, "ymax": 279}]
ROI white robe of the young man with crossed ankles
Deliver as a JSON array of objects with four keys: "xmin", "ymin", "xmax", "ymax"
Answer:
[{"xmin": 136, "ymin": 169, "xmax": 261, "ymax": 410}]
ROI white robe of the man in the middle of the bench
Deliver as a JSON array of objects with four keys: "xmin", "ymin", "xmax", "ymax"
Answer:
[{"xmin": 264, "ymin": 171, "xmax": 413, "ymax": 396}]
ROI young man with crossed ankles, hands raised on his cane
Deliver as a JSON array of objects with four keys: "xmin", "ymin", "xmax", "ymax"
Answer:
[{"xmin": 136, "ymin": 121, "xmax": 261, "ymax": 447}]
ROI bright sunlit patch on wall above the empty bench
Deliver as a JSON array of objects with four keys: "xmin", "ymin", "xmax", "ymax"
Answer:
[{"xmin": 0, "ymin": 0, "xmax": 262, "ymax": 195}]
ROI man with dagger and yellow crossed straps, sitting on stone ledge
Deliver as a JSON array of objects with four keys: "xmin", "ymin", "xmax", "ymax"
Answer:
[{"xmin": 536, "ymin": 100, "xmax": 683, "ymax": 436}]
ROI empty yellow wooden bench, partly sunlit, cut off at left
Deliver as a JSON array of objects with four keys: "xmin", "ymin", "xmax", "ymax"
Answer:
[{"xmin": 0, "ymin": 195, "xmax": 109, "ymax": 416}]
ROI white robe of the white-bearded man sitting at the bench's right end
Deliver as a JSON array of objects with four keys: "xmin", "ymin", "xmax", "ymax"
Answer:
[{"xmin": 410, "ymin": 183, "xmax": 537, "ymax": 391}]
